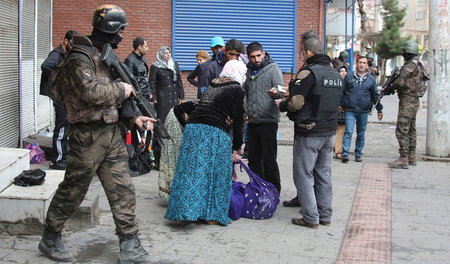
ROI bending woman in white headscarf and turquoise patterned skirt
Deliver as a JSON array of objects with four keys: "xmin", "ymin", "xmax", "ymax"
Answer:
[{"xmin": 165, "ymin": 60, "xmax": 247, "ymax": 225}]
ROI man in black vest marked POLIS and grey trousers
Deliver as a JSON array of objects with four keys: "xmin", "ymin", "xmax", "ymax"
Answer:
[{"xmin": 275, "ymin": 32, "xmax": 342, "ymax": 228}]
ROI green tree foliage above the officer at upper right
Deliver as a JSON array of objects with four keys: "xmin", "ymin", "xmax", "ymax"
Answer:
[{"xmin": 376, "ymin": 0, "xmax": 409, "ymax": 59}]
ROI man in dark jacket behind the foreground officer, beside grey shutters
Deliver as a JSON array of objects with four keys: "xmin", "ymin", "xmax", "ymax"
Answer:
[{"xmin": 40, "ymin": 30, "xmax": 78, "ymax": 170}]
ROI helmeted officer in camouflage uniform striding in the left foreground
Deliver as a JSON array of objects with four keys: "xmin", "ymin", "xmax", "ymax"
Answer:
[{"xmin": 39, "ymin": 5, "xmax": 156, "ymax": 263}]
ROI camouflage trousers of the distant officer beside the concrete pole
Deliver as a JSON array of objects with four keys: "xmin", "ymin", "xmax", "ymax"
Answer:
[{"xmin": 395, "ymin": 95, "xmax": 420, "ymax": 154}]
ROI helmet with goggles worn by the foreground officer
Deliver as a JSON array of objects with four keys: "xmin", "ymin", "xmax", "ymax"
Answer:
[{"xmin": 92, "ymin": 5, "xmax": 128, "ymax": 34}]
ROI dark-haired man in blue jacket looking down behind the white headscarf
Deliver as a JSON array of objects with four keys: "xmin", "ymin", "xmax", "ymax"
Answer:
[{"xmin": 198, "ymin": 39, "xmax": 245, "ymax": 90}]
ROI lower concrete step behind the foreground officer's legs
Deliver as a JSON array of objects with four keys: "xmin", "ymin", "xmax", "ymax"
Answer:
[{"xmin": 0, "ymin": 170, "xmax": 99, "ymax": 235}]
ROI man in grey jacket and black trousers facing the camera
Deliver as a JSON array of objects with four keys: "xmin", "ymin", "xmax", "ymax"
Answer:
[{"xmin": 244, "ymin": 42, "xmax": 284, "ymax": 191}]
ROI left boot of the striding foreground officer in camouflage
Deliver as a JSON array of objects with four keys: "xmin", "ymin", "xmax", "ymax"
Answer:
[{"xmin": 39, "ymin": 229, "xmax": 74, "ymax": 262}]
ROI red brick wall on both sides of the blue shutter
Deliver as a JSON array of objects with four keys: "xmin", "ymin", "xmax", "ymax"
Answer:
[{"xmin": 53, "ymin": 0, "xmax": 323, "ymax": 99}]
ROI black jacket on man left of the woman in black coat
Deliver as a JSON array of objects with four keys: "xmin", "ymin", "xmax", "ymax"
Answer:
[{"xmin": 125, "ymin": 51, "xmax": 154, "ymax": 98}]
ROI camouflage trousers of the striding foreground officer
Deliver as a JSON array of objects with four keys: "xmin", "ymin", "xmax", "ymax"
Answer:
[{"xmin": 45, "ymin": 122, "xmax": 138, "ymax": 235}]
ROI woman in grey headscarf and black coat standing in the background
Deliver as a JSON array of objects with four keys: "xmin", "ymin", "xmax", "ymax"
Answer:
[{"xmin": 149, "ymin": 46, "xmax": 184, "ymax": 170}]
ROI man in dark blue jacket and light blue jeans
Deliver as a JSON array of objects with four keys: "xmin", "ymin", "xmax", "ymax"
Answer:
[{"xmin": 340, "ymin": 56, "xmax": 383, "ymax": 163}]
